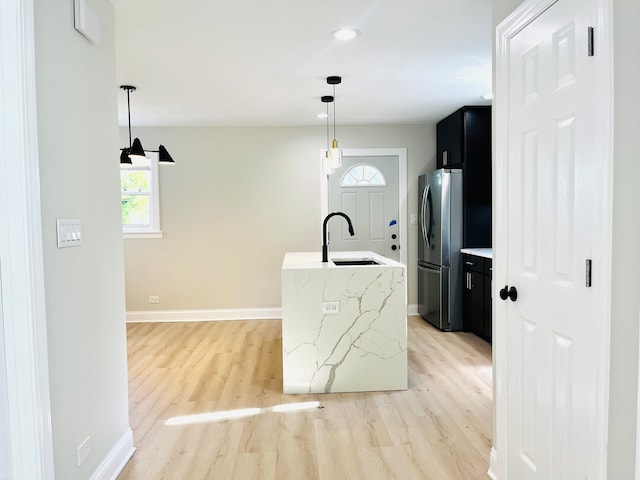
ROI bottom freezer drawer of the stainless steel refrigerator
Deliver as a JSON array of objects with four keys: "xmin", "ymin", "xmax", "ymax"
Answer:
[{"xmin": 418, "ymin": 263, "xmax": 462, "ymax": 330}]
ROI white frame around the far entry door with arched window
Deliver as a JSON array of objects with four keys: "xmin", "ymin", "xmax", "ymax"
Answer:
[{"xmin": 319, "ymin": 148, "xmax": 409, "ymax": 265}]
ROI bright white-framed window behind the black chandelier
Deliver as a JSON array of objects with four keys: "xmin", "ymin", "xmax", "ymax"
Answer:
[{"xmin": 120, "ymin": 152, "xmax": 162, "ymax": 238}]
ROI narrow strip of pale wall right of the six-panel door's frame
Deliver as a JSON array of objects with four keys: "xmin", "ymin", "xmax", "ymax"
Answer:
[{"xmin": 596, "ymin": 0, "xmax": 640, "ymax": 479}]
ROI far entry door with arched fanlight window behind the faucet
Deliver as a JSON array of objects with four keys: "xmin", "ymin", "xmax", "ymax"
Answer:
[{"xmin": 327, "ymin": 156, "xmax": 400, "ymax": 260}]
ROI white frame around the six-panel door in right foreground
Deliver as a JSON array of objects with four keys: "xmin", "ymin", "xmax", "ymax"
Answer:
[{"xmin": 488, "ymin": 0, "xmax": 613, "ymax": 480}]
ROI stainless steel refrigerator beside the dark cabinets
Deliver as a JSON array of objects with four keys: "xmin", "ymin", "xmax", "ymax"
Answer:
[{"xmin": 418, "ymin": 169, "xmax": 462, "ymax": 330}]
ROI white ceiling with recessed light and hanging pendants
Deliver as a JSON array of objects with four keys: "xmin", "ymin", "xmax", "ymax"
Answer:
[{"xmin": 112, "ymin": 0, "xmax": 492, "ymax": 126}]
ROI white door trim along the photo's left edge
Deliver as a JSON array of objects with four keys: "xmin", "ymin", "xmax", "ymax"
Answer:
[{"xmin": 0, "ymin": 0, "xmax": 54, "ymax": 480}]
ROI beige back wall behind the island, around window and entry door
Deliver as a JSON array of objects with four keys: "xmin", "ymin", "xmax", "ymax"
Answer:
[{"xmin": 120, "ymin": 124, "xmax": 436, "ymax": 311}]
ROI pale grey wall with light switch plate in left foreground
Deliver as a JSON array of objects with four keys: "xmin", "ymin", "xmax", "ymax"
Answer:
[{"xmin": 35, "ymin": 0, "xmax": 129, "ymax": 480}]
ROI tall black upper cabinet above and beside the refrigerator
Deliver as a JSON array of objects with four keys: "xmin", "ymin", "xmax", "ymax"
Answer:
[{"xmin": 436, "ymin": 106, "xmax": 491, "ymax": 248}]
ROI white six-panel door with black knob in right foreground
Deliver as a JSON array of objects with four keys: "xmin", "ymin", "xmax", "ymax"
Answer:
[{"xmin": 498, "ymin": 0, "xmax": 608, "ymax": 480}]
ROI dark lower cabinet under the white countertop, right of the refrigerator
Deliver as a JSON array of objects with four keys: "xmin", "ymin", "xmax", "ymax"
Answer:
[{"xmin": 462, "ymin": 253, "xmax": 492, "ymax": 342}]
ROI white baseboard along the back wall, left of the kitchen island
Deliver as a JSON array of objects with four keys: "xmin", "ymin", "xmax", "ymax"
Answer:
[{"xmin": 127, "ymin": 308, "xmax": 282, "ymax": 323}]
